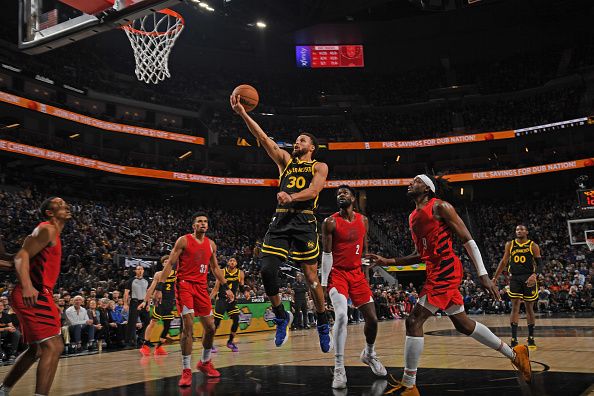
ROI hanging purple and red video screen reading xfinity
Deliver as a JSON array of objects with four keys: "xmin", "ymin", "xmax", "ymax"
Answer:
[{"xmin": 295, "ymin": 45, "xmax": 365, "ymax": 69}]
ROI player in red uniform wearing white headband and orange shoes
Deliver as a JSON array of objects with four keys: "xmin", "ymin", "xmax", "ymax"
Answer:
[{"xmin": 369, "ymin": 175, "xmax": 531, "ymax": 395}]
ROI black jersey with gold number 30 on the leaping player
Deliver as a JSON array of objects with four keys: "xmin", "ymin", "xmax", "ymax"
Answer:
[{"xmin": 277, "ymin": 158, "xmax": 318, "ymax": 213}]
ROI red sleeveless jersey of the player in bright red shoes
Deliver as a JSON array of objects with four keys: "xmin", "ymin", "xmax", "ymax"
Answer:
[{"xmin": 177, "ymin": 234, "xmax": 212, "ymax": 285}]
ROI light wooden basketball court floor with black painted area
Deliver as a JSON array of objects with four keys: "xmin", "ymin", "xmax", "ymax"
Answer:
[{"xmin": 0, "ymin": 314, "xmax": 594, "ymax": 396}]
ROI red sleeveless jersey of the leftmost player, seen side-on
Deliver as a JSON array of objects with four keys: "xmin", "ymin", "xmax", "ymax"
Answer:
[{"xmin": 29, "ymin": 221, "xmax": 62, "ymax": 290}]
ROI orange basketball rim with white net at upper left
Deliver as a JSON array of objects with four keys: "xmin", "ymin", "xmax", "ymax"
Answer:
[{"xmin": 122, "ymin": 8, "xmax": 185, "ymax": 84}]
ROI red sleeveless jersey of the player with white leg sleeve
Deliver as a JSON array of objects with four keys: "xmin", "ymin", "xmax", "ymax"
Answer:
[{"xmin": 332, "ymin": 212, "xmax": 365, "ymax": 271}]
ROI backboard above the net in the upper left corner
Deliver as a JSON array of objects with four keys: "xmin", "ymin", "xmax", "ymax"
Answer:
[{"xmin": 19, "ymin": 0, "xmax": 182, "ymax": 54}]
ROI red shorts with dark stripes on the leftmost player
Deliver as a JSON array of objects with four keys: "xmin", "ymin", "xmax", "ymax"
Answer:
[{"xmin": 10, "ymin": 285, "xmax": 62, "ymax": 344}]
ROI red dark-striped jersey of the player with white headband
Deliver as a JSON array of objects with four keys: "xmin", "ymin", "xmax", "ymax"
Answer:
[{"xmin": 409, "ymin": 198, "xmax": 463, "ymax": 290}]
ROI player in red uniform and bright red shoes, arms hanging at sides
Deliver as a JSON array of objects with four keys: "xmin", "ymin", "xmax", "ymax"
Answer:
[{"xmin": 153, "ymin": 213, "xmax": 235, "ymax": 386}]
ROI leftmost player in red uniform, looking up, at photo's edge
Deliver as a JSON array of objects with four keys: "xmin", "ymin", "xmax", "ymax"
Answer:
[{"xmin": 0, "ymin": 197, "xmax": 71, "ymax": 395}]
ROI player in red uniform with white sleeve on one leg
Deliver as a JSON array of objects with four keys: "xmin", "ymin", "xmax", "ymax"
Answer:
[{"xmin": 321, "ymin": 185, "xmax": 387, "ymax": 389}]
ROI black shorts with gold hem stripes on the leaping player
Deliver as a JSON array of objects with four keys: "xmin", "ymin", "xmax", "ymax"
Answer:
[{"xmin": 262, "ymin": 209, "xmax": 320, "ymax": 263}]
